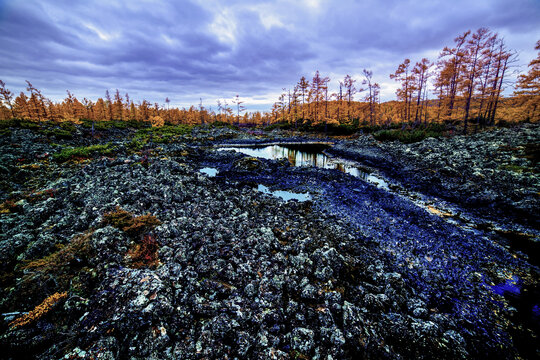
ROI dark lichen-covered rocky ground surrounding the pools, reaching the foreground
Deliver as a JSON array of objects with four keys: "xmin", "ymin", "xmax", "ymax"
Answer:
[{"xmin": 0, "ymin": 122, "xmax": 540, "ymax": 359}]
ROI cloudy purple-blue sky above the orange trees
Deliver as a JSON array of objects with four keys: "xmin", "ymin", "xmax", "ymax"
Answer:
[{"xmin": 0, "ymin": 0, "xmax": 540, "ymax": 111}]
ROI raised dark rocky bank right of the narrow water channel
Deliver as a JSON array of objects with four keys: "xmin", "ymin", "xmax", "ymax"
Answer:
[{"xmin": 329, "ymin": 124, "xmax": 540, "ymax": 229}]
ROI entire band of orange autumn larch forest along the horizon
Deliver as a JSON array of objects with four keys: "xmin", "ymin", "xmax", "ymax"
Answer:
[{"xmin": 0, "ymin": 28, "xmax": 540, "ymax": 132}]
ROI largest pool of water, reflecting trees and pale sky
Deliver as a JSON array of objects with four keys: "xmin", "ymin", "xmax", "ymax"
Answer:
[{"xmin": 218, "ymin": 144, "xmax": 388, "ymax": 190}]
